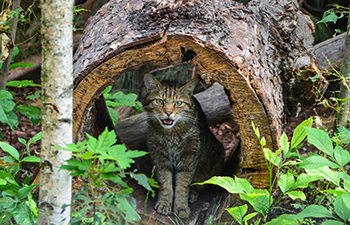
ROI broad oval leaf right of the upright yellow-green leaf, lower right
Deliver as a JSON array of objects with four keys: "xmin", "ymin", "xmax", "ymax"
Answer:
[{"xmin": 305, "ymin": 127, "xmax": 333, "ymax": 158}]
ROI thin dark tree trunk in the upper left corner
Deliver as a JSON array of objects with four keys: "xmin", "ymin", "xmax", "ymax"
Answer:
[{"xmin": 0, "ymin": 0, "xmax": 21, "ymax": 90}]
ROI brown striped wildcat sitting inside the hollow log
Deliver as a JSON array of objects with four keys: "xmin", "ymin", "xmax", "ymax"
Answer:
[{"xmin": 143, "ymin": 74, "xmax": 224, "ymax": 218}]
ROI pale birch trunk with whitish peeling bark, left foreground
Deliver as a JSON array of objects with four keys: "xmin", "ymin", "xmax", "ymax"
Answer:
[{"xmin": 38, "ymin": 0, "xmax": 74, "ymax": 224}]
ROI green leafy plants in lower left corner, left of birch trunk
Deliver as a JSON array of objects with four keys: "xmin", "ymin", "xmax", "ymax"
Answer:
[{"xmin": 0, "ymin": 132, "xmax": 41, "ymax": 224}]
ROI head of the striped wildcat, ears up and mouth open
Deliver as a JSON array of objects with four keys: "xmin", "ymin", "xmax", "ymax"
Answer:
[{"xmin": 144, "ymin": 74, "xmax": 198, "ymax": 128}]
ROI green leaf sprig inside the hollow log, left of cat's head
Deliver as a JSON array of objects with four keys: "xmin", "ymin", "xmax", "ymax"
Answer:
[{"xmin": 103, "ymin": 86, "xmax": 142, "ymax": 124}]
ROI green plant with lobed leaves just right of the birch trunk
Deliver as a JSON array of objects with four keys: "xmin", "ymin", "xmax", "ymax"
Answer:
[{"xmin": 60, "ymin": 128, "xmax": 158, "ymax": 224}]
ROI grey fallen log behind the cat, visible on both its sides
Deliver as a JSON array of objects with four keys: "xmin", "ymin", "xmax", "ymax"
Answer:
[{"xmin": 115, "ymin": 83, "xmax": 232, "ymax": 149}]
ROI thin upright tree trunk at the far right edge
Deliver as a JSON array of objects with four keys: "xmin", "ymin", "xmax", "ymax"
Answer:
[{"xmin": 336, "ymin": 12, "xmax": 350, "ymax": 127}]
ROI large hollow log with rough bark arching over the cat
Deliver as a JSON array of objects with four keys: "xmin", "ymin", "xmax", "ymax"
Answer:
[{"xmin": 74, "ymin": 0, "xmax": 326, "ymax": 224}]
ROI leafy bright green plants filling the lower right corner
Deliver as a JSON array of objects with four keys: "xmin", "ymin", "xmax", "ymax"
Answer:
[{"xmin": 200, "ymin": 118, "xmax": 350, "ymax": 225}]
